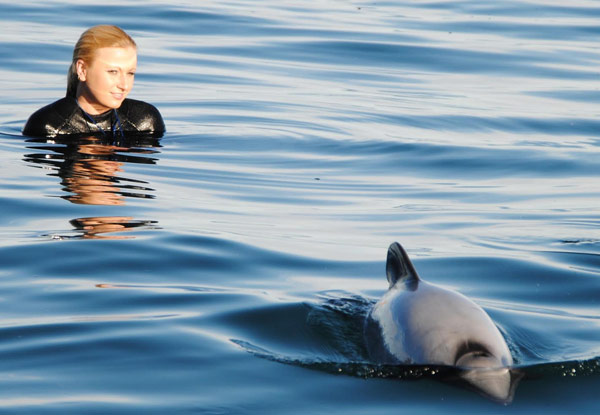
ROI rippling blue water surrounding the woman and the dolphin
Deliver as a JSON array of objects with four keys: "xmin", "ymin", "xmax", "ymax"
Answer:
[{"xmin": 0, "ymin": 0, "xmax": 600, "ymax": 414}]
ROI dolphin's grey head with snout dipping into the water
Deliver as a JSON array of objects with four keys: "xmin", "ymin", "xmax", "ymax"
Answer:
[{"xmin": 456, "ymin": 347, "xmax": 520, "ymax": 404}]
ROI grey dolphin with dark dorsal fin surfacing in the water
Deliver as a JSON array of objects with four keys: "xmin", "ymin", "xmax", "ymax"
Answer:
[{"xmin": 364, "ymin": 242, "xmax": 519, "ymax": 404}]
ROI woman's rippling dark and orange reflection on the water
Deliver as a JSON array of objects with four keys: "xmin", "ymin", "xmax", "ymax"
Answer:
[{"xmin": 23, "ymin": 137, "xmax": 160, "ymax": 239}]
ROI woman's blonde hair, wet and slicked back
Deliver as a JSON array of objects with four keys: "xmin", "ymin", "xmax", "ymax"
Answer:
[{"xmin": 67, "ymin": 25, "xmax": 137, "ymax": 98}]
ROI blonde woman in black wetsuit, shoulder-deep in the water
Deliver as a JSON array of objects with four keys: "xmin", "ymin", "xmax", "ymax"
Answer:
[{"xmin": 23, "ymin": 25, "xmax": 165, "ymax": 137}]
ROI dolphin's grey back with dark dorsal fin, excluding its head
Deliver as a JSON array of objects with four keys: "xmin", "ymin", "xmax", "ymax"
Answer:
[{"xmin": 365, "ymin": 242, "xmax": 512, "ymax": 365}]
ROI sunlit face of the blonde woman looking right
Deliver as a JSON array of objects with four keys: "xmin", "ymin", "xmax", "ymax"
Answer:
[{"xmin": 76, "ymin": 47, "xmax": 137, "ymax": 114}]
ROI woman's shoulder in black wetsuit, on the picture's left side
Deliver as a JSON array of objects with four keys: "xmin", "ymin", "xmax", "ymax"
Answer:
[{"xmin": 23, "ymin": 97, "xmax": 77, "ymax": 137}]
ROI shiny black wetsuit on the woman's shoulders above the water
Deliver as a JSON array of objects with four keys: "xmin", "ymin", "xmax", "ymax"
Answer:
[{"xmin": 23, "ymin": 97, "xmax": 165, "ymax": 137}]
